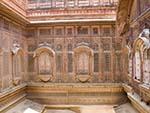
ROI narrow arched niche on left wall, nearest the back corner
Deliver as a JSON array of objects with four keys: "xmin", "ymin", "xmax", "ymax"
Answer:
[{"xmin": 12, "ymin": 45, "xmax": 25, "ymax": 85}]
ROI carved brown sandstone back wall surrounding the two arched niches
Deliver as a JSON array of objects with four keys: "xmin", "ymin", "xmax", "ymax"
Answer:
[{"xmin": 27, "ymin": 22, "xmax": 122, "ymax": 82}]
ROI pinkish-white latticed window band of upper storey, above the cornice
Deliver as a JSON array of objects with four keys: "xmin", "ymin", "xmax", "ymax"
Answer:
[{"xmin": 28, "ymin": 0, "xmax": 118, "ymax": 9}]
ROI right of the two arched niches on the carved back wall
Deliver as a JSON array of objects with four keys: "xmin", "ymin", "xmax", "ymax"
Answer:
[{"xmin": 74, "ymin": 45, "xmax": 94, "ymax": 82}]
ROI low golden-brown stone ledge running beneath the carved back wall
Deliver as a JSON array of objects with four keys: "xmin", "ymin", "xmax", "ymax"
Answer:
[{"xmin": 26, "ymin": 83, "xmax": 127, "ymax": 105}]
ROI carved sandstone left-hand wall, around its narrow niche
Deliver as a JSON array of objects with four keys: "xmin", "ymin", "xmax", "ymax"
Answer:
[{"xmin": 0, "ymin": 15, "xmax": 27, "ymax": 90}]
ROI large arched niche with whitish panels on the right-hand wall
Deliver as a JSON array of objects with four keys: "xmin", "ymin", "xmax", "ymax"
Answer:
[{"xmin": 133, "ymin": 37, "xmax": 150, "ymax": 80}]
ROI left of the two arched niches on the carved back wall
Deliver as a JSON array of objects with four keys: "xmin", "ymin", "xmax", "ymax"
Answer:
[{"xmin": 33, "ymin": 45, "xmax": 55, "ymax": 82}]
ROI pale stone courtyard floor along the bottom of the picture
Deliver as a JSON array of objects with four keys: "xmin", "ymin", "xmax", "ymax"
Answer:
[{"xmin": 4, "ymin": 99, "xmax": 138, "ymax": 113}]
